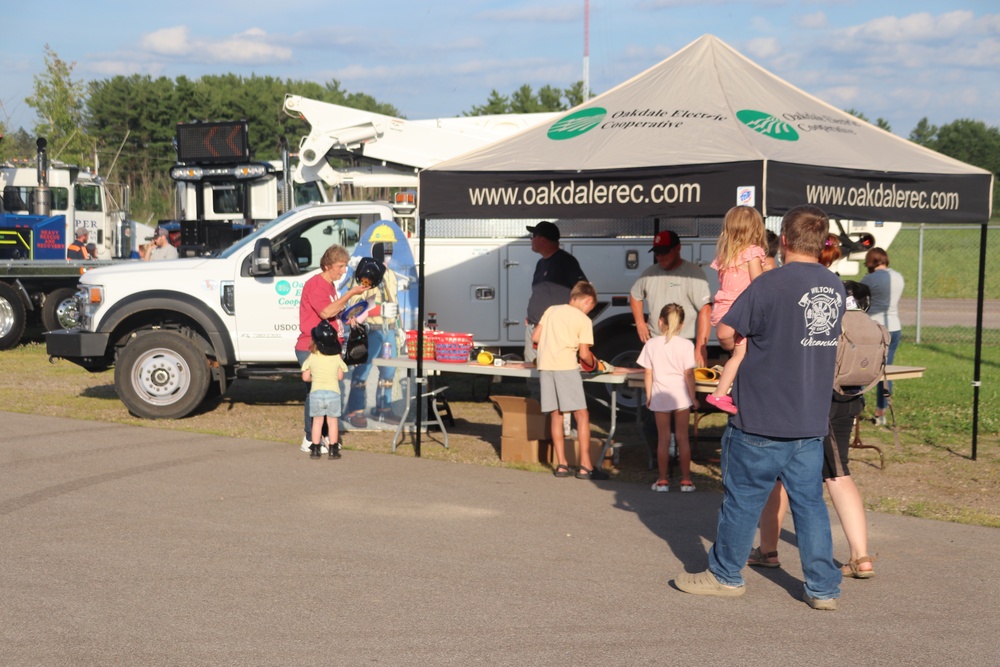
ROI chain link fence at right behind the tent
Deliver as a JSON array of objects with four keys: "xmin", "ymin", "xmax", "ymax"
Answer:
[{"xmin": 842, "ymin": 224, "xmax": 1000, "ymax": 346}]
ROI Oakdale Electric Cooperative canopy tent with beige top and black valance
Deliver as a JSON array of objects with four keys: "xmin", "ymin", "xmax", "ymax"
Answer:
[{"xmin": 417, "ymin": 35, "xmax": 993, "ymax": 457}]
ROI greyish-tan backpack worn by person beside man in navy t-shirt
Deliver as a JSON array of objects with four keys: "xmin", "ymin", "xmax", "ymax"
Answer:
[{"xmin": 833, "ymin": 310, "xmax": 889, "ymax": 400}]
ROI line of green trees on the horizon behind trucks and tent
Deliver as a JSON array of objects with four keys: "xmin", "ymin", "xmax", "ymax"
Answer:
[{"xmin": 0, "ymin": 45, "xmax": 1000, "ymax": 219}]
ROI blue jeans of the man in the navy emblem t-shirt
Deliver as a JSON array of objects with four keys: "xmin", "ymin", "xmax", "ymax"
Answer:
[{"xmin": 708, "ymin": 424, "xmax": 842, "ymax": 599}]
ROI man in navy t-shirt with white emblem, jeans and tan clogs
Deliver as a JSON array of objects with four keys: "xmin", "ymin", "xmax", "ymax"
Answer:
[{"xmin": 675, "ymin": 206, "xmax": 845, "ymax": 609}]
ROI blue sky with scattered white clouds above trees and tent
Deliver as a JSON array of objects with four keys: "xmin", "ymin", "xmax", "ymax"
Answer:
[{"xmin": 0, "ymin": 0, "xmax": 1000, "ymax": 136}]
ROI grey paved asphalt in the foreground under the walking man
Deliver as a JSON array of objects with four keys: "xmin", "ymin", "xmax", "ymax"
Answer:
[{"xmin": 0, "ymin": 413, "xmax": 1000, "ymax": 667}]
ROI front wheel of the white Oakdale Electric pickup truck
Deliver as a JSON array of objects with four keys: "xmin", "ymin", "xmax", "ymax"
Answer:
[{"xmin": 115, "ymin": 331, "xmax": 210, "ymax": 419}]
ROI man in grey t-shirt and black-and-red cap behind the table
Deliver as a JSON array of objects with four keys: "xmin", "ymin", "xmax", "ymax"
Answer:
[{"xmin": 629, "ymin": 229, "xmax": 712, "ymax": 366}]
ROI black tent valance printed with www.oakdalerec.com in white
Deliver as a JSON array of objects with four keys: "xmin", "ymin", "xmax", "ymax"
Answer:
[{"xmin": 420, "ymin": 161, "xmax": 992, "ymax": 222}]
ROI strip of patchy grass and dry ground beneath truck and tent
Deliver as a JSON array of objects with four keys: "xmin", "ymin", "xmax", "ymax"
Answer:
[{"xmin": 0, "ymin": 339, "xmax": 1000, "ymax": 527}]
